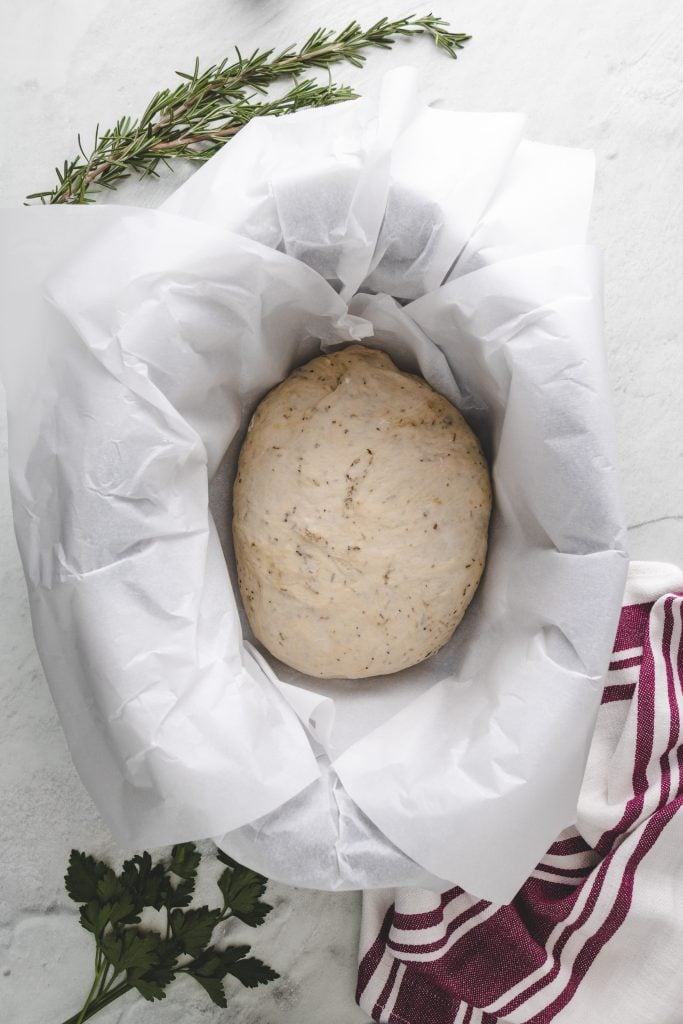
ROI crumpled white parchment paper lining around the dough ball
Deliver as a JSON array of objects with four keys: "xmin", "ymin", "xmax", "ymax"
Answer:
[{"xmin": 0, "ymin": 72, "xmax": 627, "ymax": 902}]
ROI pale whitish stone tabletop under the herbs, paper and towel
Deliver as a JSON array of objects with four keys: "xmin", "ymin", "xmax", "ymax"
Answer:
[{"xmin": 0, "ymin": 0, "xmax": 683, "ymax": 1024}]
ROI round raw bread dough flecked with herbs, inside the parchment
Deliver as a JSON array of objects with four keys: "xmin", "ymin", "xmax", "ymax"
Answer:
[{"xmin": 232, "ymin": 345, "xmax": 492, "ymax": 679}]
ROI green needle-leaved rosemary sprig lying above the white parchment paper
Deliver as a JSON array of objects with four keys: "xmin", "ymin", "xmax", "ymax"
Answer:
[{"xmin": 27, "ymin": 14, "xmax": 470, "ymax": 204}]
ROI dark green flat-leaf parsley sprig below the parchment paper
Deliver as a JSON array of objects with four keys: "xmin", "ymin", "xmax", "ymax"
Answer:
[{"xmin": 59, "ymin": 843, "xmax": 279, "ymax": 1024}]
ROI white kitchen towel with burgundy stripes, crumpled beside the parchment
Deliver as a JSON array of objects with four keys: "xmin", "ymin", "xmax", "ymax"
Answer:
[{"xmin": 357, "ymin": 562, "xmax": 683, "ymax": 1024}]
